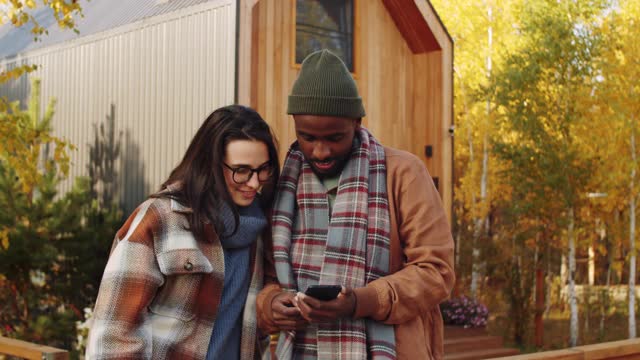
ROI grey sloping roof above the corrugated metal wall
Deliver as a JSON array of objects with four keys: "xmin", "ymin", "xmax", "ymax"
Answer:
[{"xmin": 0, "ymin": 0, "xmax": 211, "ymax": 59}]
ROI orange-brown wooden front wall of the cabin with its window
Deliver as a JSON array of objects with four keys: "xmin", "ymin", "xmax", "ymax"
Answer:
[{"xmin": 238, "ymin": 0, "xmax": 453, "ymax": 220}]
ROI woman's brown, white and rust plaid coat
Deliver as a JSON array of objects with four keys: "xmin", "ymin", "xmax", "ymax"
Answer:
[{"xmin": 87, "ymin": 199, "xmax": 263, "ymax": 359}]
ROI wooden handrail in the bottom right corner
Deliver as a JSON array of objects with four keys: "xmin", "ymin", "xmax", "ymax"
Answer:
[{"xmin": 500, "ymin": 338, "xmax": 640, "ymax": 360}]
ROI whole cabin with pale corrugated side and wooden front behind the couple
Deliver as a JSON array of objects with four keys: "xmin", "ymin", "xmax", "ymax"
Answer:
[{"xmin": 0, "ymin": 0, "xmax": 453, "ymax": 219}]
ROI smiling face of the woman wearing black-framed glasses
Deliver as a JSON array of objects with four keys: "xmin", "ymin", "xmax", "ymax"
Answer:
[{"xmin": 222, "ymin": 140, "xmax": 270, "ymax": 206}]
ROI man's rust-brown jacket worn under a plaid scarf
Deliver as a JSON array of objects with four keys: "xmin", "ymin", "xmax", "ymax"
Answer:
[{"xmin": 257, "ymin": 148, "xmax": 455, "ymax": 359}]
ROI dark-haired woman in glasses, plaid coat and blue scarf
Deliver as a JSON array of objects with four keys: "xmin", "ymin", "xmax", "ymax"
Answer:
[{"xmin": 87, "ymin": 105, "xmax": 279, "ymax": 359}]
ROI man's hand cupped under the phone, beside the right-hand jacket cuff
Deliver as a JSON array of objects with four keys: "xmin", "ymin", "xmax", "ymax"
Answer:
[{"xmin": 294, "ymin": 286, "xmax": 356, "ymax": 323}]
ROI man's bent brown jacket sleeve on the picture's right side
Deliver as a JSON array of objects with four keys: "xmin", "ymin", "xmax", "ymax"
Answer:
[{"xmin": 354, "ymin": 157, "xmax": 455, "ymax": 324}]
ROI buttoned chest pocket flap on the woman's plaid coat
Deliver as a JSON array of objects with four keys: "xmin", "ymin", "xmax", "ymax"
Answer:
[{"xmin": 158, "ymin": 249, "xmax": 213, "ymax": 275}]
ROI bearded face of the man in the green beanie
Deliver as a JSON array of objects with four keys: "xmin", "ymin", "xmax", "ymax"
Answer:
[{"xmin": 293, "ymin": 115, "xmax": 361, "ymax": 178}]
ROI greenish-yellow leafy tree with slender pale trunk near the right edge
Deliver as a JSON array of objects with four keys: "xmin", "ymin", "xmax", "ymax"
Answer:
[{"xmin": 495, "ymin": 1, "xmax": 605, "ymax": 346}]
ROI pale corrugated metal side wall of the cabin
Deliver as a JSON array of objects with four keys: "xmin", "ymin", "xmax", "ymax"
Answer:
[{"xmin": 0, "ymin": 0, "xmax": 236, "ymax": 211}]
